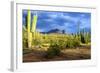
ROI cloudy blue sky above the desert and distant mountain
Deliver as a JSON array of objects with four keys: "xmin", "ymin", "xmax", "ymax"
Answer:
[{"xmin": 22, "ymin": 10, "xmax": 91, "ymax": 33}]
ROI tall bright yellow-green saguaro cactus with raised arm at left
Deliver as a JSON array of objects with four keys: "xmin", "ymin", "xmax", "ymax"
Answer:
[{"xmin": 27, "ymin": 10, "xmax": 37, "ymax": 48}]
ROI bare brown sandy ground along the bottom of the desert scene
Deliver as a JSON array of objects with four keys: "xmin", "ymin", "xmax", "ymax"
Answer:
[{"xmin": 23, "ymin": 46, "xmax": 91, "ymax": 62}]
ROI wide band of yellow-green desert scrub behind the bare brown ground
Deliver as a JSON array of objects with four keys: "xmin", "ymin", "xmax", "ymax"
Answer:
[{"xmin": 23, "ymin": 26, "xmax": 91, "ymax": 50}]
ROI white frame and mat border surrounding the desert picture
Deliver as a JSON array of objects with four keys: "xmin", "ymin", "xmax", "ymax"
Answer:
[{"xmin": 12, "ymin": 2, "xmax": 97, "ymax": 71}]
